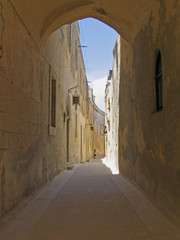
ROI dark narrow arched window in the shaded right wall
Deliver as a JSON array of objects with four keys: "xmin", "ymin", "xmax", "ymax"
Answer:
[{"xmin": 155, "ymin": 51, "xmax": 163, "ymax": 111}]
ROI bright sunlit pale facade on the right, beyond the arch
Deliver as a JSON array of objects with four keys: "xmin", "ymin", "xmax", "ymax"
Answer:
[{"xmin": 104, "ymin": 35, "xmax": 120, "ymax": 174}]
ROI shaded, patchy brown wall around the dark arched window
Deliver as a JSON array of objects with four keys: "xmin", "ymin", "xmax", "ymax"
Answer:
[{"xmin": 119, "ymin": 0, "xmax": 180, "ymax": 227}]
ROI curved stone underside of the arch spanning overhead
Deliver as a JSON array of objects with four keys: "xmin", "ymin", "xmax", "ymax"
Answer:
[{"xmin": 11, "ymin": 0, "xmax": 153, "ymax": 45}]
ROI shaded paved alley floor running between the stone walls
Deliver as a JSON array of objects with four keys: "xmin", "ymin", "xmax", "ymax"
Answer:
[{"xmin": 0, "ymin": 159, "xmax": 180, "ymax": 240}]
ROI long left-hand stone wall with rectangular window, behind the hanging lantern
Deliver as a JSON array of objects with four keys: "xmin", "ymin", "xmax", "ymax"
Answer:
[{"xmin": 0, "ymin": 1, "xmax": 104, "ymax": 216}]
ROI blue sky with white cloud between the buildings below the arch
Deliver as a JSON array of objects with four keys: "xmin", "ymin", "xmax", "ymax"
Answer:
[{"xmin": 78, "ymin": 18, "xmax": 117, "ymax": 110}]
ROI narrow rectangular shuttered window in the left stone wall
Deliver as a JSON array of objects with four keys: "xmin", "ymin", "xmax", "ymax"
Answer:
[{"xmin": 51, "ymin": 79, "xmax": 56, "ymax": 127}]
